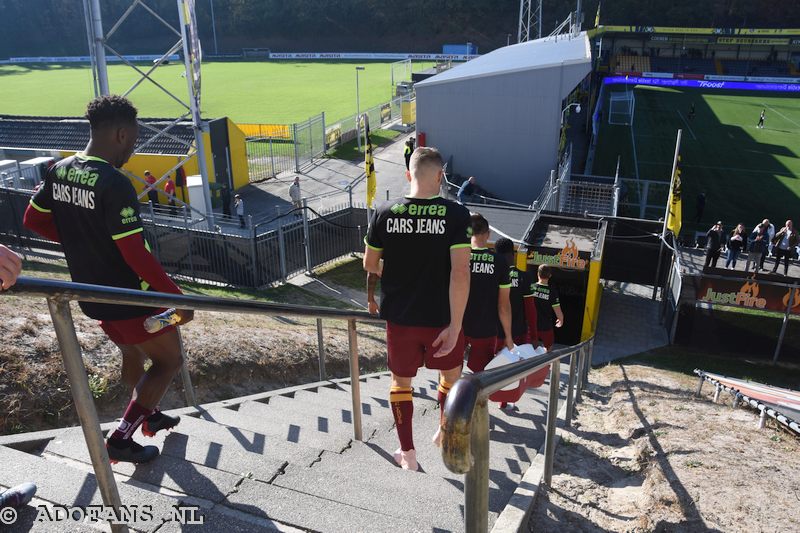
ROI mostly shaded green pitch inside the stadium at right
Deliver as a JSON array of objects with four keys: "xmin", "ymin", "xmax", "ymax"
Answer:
[{"xmin": 592, "ymin": 85, "xmax": 800, "ymax": 236}]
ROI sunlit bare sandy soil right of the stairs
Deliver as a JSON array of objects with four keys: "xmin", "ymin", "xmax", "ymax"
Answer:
[{"xmin": 528, "ymin": 364, "xmax": 800, "ymax": 532}]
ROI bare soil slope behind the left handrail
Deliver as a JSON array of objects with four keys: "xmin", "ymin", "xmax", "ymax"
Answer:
[{"xmin": 0, "ymin": 288, "xmax": 386, "ymax": 434}]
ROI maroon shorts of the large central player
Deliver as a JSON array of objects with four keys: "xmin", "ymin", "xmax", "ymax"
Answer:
[{"xmin": 386, "ymin": 322, "xmax": 464, "ymax": 378}]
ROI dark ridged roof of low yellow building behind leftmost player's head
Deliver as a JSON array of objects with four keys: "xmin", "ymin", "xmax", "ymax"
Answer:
[{"xmin": 0, "ymin": 115, "xmax": 194, "ymax": 155}]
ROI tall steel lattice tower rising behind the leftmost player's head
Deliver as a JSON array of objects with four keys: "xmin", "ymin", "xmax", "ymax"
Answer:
[{"xmin": 83, "ymin": 0, "xmax": 214, "ymax": 228}]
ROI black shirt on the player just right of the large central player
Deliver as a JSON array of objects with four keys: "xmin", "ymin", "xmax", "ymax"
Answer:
[{"xmin": 464, "ymin": 248, "xmax": 511, "ymax": 339}]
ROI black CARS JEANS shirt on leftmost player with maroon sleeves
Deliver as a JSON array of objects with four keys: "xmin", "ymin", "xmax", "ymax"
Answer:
[{"xmin": 31, "ymin": 154, "xmax": 158, "ymax": 320}]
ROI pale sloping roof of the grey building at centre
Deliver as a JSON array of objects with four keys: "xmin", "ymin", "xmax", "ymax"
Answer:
[{"xmin": 416, "ymin": 32, "xmax": 592, "ymax": 87}]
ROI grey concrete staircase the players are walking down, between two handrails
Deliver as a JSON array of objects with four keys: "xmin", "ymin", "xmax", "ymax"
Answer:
[{"xmin": 0, "ymin": 365, "xmax": 566, "ymax": 533}]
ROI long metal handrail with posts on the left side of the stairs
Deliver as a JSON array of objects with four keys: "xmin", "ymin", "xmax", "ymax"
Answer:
[{"xmin": 3, "ymin": 277, "xmax": 381, "ymax": 533}]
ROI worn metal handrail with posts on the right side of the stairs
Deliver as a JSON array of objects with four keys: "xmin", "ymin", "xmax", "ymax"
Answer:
[{"xmin": 442, "ymin": 337, "xmax": 594, "ymax": 533}]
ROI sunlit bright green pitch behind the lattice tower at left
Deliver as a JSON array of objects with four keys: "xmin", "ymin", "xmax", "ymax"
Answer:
[{"xmin": 0, "ymin": 61, "xmax": 431, "ymax": 123}]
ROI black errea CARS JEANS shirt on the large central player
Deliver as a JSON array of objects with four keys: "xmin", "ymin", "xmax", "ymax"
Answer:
[{"xmin": 365, "ymin": 196, "xmax": 471, "ymax": 327}]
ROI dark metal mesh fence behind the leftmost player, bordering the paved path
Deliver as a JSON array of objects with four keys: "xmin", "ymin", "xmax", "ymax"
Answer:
[{"xmin": 0, "ymin": 189, "xmax": 367, "ymax": 288}]
